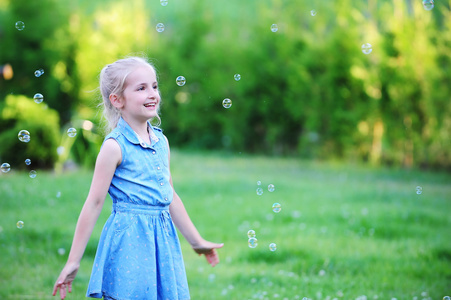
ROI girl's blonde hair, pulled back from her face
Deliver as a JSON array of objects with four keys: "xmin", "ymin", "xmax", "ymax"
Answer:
[{"xmin": 99, "ymin": 56, "xmax": 161, "ymax": 133}]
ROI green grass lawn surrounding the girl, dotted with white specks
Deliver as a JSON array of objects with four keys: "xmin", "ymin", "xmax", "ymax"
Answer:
[{"xmin": 0, "ymin": 150, "xmax": 451, "ymax": 300}]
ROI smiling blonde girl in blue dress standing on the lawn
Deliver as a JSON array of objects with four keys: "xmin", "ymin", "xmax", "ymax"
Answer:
[{"xmin": 53, "ymin": 57, "xmax": 223, "ymax": 300}]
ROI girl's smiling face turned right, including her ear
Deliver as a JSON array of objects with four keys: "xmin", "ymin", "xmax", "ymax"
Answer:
[{"xmin": 110, "ymin": 66, "xmax": 160, "ymax": 122}]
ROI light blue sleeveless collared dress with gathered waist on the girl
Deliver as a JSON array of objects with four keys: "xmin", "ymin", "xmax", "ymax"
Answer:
[{"xmin": 86, "ymin": 118, "xmax": 190, "ymax": 300}]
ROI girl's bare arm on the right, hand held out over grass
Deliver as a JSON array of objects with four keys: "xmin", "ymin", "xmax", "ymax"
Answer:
[{"xmin": 168, "ymin": 137, "xmax": 224, "ymax": 267}]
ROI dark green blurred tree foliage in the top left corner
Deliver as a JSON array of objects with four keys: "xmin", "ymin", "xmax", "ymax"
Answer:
[{"xmin": 0, "ymin": 0, "xmax": 79, "ymax": 124}]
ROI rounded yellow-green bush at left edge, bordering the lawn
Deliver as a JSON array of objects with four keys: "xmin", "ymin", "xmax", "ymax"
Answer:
[{"xmin": 0, "ymin": 95, "xmax": 60, "ymax": 169}]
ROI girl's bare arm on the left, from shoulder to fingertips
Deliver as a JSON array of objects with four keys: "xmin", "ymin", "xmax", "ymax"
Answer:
[{"xmin": 53, "ymin": 139, "xmax": 121, "ymax": 299}]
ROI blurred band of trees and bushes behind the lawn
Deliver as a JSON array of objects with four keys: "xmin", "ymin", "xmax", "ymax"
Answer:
[{"xmin": 0, "ymin": 0, "xmax": 451, "ymax": 169}]
